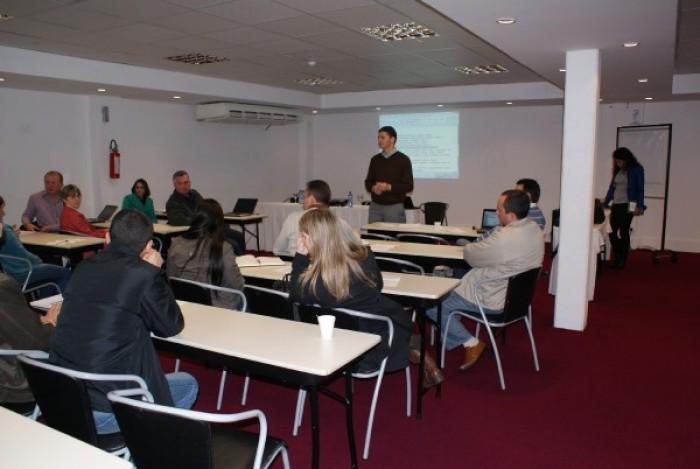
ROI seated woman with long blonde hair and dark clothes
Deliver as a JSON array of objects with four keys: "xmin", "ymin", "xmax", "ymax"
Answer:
[{"xmin": 290, "ymin": 209, "xmax": 442, "ymax": 386}]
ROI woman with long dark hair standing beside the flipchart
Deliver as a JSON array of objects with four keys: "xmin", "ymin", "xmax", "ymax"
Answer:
[{"xmin": 605, "ymin": 147, "xmax": 646, "ymax": 269}]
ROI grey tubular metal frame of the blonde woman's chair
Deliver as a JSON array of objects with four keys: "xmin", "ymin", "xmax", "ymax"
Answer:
[{"xmin": 292, "ymin": 305, "xmax": 411, "ymax": 459}]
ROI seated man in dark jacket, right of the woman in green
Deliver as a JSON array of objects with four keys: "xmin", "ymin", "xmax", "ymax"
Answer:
[{"xmin": 165, "ymin": 170, "xmax": 245, "ymax": 256}]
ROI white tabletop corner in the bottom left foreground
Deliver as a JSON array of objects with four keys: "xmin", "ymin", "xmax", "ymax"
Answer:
[{"xmin": 0, "ymin": 407, "xmax": 133, "ymax": 469}]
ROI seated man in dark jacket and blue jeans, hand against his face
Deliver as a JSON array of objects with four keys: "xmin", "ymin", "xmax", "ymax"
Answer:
[{"xmin": 50, "ymin": 209, "xmax": 198, "ymax": 433}]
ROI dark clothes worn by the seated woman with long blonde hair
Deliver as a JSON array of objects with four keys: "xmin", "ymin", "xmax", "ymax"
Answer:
[{"xmin": 289, "ymin": 251, "xmax": 413, "ymax": 371}]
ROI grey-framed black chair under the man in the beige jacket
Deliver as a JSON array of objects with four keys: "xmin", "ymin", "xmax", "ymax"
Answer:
[{"xmin": 440, "ymin": 267, "xmax": 541, "ymax": 391}]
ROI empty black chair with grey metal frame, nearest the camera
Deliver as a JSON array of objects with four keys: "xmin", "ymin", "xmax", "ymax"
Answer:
[{"xmin": 107, "ymin": 389, "xmax": 267, "ymax": 469}]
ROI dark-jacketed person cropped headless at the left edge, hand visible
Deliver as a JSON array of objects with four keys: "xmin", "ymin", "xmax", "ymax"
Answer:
[{"xmin": 0, "ymin": 227, "xmax": 60, "ymax": 412}]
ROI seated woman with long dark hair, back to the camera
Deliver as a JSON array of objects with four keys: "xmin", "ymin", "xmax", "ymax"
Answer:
[{"xmin": 167, "ymin": 199, "xmax": 245, "ymax": 309}]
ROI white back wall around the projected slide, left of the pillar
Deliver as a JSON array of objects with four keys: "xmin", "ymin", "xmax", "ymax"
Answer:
[{"xmin": 309, "ymin": 106, "xmax": 562, "ymax": 232}]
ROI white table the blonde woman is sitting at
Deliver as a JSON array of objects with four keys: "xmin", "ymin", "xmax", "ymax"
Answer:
[{"xmin": 240, "ymin": 262, "xmax": 460, "ymax": 419}]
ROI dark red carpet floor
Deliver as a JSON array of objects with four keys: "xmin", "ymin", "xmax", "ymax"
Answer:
[{"xmin": 163, "ymin": 252, "xmax": 700, "ymax": 469}]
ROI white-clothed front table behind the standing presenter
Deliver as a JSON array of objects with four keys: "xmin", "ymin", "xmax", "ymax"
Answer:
[{"xmin": 255, "ymin": 202, "xmax": 423, "ymax": 251}]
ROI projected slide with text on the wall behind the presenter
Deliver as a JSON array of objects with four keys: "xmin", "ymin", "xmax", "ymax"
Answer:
[{"xmin": 379, "ymin": 112, "xmax": 459, "ymax": 179}]
